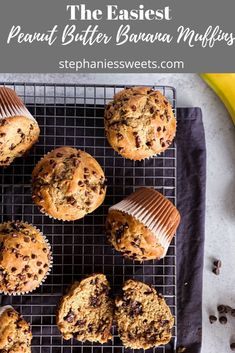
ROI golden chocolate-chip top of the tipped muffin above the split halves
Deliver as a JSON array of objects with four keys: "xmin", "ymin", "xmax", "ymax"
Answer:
[{"xmin": 106, "ymin": 210, "xmax": 164, "ymax": 261}]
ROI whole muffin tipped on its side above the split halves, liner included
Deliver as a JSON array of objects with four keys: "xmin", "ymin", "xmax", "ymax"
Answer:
[{"xmin": 106, "ymin": 188, "xmax": 180, "ymax": 261}]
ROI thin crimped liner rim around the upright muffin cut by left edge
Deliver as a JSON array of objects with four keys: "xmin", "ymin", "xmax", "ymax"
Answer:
[{"xmin": 0, "ymin": 220, "xmax": 53, "ymax": 296}]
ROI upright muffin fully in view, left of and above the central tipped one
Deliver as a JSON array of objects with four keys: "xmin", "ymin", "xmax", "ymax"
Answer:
[{"xmin": 33, "ymin": 146, "xmax": 106, "ymax": 221}]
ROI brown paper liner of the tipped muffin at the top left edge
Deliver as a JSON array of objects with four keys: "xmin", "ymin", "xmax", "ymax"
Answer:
[{"xmin": 0, "ymin": 87, "xmax": 37, "ymax": 124}]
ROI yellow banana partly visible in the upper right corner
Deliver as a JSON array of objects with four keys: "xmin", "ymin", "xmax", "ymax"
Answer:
[{"xmin": 200, "ymin": 73, "xmax": 235, "ymax": 124}]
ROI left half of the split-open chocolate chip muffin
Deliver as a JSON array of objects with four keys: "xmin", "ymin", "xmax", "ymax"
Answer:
[{"xmin": 57, "ymin": 274, "xmax": 113, "ymax": 343}]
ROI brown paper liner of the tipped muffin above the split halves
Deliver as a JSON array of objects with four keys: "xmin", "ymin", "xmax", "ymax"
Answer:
[{"xmin": 109, "ymin": 187, "xmax": 180, "ymax": 258}]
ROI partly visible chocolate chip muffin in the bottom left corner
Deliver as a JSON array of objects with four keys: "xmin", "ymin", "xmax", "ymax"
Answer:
[{"xmin": 0, "ymin": 306, "xmax": 32, "ymax": 353}]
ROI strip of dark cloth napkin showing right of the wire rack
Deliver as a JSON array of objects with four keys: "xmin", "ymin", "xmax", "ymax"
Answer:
[{"xmin": 177, "ymin": 108, "xmax": 206, "ymax": 353}]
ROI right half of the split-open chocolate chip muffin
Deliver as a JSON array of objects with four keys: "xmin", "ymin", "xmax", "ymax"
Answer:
[{"xmin": 115, "ymin": 280, "xmax": 174, "ymax": 349}]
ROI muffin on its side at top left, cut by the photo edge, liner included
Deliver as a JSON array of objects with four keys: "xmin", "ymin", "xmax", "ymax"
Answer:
[{"xmin": 0, "ymin": 87, "xmax": 40, "ymax": 166}]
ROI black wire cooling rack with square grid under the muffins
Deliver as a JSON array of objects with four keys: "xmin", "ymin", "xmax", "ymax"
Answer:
[{"xmin": 0, "ymin": 83, "xmax": 177, "ymax": 353}]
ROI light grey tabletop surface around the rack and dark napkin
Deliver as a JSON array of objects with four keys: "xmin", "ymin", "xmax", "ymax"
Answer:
[{"xmin": 0, "ymin": 74, "xmax": 235, "ymax": 353}]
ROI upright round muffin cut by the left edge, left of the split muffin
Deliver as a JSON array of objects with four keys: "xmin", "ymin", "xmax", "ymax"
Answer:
[{"xmin": 0, "ymin": 221, "xmax": 52, "ymax": 294}]
